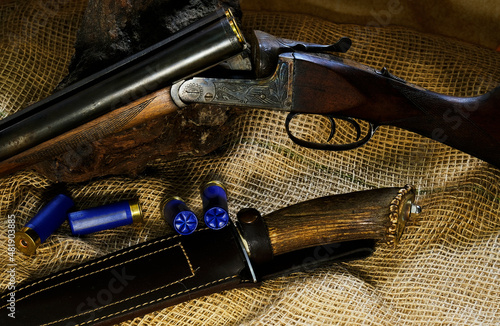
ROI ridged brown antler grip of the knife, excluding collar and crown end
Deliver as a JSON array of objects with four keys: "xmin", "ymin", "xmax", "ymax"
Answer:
[{"xmin": 264, "ymin": 188, "xmax": 399, "ymax": 255}]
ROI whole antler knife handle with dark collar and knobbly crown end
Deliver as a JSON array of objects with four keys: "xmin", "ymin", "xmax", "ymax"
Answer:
[{"xmin": 238, "ymin": 185, "xmax": 420, "ymax": 262}]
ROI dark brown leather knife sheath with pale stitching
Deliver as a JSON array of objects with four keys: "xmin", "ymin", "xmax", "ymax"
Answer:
[{"xmin": 0, "ymin": 224, "xmax": 374, "ymax": 326}]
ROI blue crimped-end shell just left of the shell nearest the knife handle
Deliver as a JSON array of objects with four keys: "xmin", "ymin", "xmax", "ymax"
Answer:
[{"xmin": 162, "ymin": 197, "xmax": 198, "ymax": 235}]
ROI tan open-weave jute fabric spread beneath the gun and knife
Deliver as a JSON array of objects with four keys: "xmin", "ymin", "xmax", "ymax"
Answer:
[{"xmin": 0, "ymin": 1, "xmax": 500, "ymax": 325}]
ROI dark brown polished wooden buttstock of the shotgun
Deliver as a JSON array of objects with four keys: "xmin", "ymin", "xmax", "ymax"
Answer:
[{"xmin": 293, "ymin": 54, "xmax": 500, "ymax": 167}]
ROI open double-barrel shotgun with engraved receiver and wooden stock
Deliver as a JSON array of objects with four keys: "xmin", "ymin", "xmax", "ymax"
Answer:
[{"xmin": 0, "ymin": 10, "xmax": 500, "ymax": 181}]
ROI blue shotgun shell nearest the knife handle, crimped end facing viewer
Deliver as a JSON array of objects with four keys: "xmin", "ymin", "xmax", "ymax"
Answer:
[{"xmin": 201, "ymin": 181, "xmax": 229, "ymax": 230}]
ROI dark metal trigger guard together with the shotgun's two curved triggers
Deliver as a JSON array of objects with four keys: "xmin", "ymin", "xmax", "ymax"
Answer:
[{"xmin": 285, "ymin": 112, "xmax": 377, "ymax": 151}]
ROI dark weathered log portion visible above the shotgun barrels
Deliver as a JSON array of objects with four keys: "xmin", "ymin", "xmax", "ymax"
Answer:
[{"xmin": 56, "ymin": 0, "xmax": 241, "ymax": 90}]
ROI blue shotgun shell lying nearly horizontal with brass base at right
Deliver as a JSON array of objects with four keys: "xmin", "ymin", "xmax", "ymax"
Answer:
[{"xmin": 68, "ymin": 200, "xmax": 143, "ymax": 236}]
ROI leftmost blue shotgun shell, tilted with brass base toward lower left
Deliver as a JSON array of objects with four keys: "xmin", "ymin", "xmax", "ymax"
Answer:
[{"xmin": 14, "ymin": 194, "xmax": 74, "ymax": 255}]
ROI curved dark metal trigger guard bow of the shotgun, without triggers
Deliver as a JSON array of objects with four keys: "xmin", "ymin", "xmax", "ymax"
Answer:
[{"xmin": 285, "ymin": 112, "xmax": 377, "ymax": 151}]
